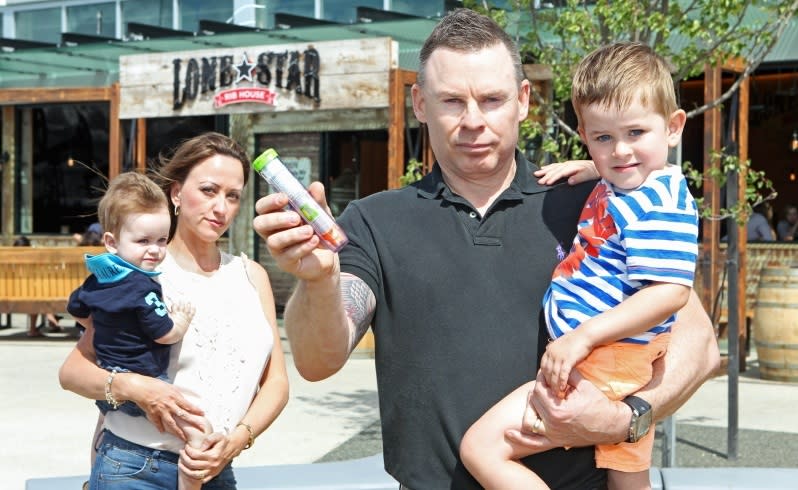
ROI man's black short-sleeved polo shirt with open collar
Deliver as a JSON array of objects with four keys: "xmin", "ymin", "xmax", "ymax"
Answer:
[{"xmin": 339, "ymin": 152, "xmax": 604, "ymax": 490}]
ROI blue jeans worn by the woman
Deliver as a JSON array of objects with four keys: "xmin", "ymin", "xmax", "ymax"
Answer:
[{"xmin": 89, "ymin": 430, "xmax": 236, "ymax": 490}]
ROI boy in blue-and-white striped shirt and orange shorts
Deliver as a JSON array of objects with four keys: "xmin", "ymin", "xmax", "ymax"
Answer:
[{"xmin": 461, "ymin": 43, "xmax": 698, "ymax": 490}]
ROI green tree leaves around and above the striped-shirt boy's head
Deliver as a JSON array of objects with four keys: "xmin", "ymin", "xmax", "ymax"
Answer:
[{"xmin": 464, "ymin": 0, "xmax": 798, "ymax": 219}]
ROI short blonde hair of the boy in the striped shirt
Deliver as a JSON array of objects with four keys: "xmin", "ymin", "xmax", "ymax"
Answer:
[{"xmin": 571, "ymin": 42, "xmax": 679, "ymax": 124}]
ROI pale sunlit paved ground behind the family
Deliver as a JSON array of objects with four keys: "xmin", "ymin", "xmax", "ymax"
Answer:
[{"xmin": 0, "ymin": 315, "xmax": 798, "ymax": 490}]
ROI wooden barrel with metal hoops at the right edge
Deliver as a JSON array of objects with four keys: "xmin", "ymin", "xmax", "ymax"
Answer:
[{"xmin": 754, "ymin": 264, "xmax": 798, "ymax": 382}]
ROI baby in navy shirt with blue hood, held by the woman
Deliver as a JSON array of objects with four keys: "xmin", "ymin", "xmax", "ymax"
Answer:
[{"xmin": 67, "ymin": 172, "xmax": 211, "ymax": 490}]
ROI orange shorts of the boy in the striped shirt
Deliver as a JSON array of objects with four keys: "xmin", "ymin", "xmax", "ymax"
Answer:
[{"xmin": 576, "ymin": 333, "xmax": 670, "ymax": 472}]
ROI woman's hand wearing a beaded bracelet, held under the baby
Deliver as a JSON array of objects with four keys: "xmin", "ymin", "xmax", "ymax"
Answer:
[{"xmin": 122, "ymin": 373, "xmax": 205, "ymax": 441}]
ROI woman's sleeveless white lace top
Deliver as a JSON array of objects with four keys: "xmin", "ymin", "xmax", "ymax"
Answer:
[{"xmin": 105, "ymin": 253, "xmax": 275, "ymax": 452}]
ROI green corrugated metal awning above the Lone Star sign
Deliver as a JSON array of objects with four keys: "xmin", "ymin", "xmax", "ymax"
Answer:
[{"xmin": 0, "ymin": 18, "xmax": 438, "ymax": 88}]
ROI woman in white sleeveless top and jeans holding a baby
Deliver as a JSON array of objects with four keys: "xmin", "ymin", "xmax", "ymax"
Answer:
[{"xmin": 59, "ymin": 133, "xmax": 288, "ymax": 490}]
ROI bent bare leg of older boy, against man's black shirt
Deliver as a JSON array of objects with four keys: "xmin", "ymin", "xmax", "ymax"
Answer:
[{"xmin": 460, "ymin": 381, "xmax": 549, "ymax": 490}]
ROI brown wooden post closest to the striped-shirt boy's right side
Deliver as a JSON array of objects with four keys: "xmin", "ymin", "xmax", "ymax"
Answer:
[{"xmin": 699, "ymin": 65, "xmax": 721, "ymax": 312}]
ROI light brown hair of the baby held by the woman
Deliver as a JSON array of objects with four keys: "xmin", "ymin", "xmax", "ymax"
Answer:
[{"xmin": 97, "ymin": 172, "xmax": 169, "ymax": 238}]
